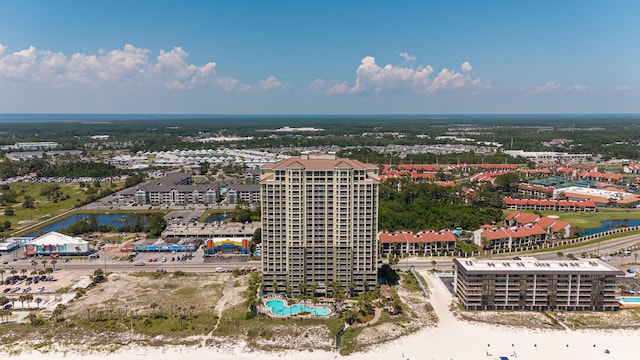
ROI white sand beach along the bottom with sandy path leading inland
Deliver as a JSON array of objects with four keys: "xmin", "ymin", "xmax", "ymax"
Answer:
[{"xmin": 3, "ymin": 272, "xmax": 640, "ymax": 360}]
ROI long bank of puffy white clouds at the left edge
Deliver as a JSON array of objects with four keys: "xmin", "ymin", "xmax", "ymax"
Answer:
[{"xmin": 0, "ymin": 44, "xmax": 278, "ymax": 91}]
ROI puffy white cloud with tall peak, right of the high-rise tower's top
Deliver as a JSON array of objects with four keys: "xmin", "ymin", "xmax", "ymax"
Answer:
[{"xmin": 328, "ymin": 56, "xmax": 482, "ymax": 95}]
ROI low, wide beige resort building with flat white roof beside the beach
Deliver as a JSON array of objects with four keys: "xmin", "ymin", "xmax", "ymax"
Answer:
[{"xmin": 453, "ymin": 257, "xmax": 624, "ymax": 311}]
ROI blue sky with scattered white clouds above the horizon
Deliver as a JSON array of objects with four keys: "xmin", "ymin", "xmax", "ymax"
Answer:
[{"xmin": 0, "ymin": 0, "xmax": 640, "ymax": 114}]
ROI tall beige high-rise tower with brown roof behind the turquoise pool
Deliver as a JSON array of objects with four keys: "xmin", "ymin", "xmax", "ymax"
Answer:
[{"xmin": 260, "ymin": 153, "xmax": 379, "ymax": 296}]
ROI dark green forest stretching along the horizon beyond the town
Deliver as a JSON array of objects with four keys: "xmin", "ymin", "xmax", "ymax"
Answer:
[{"xmin": 0, "ymin": 115, "xmax": 640, "ymax": 163}]
